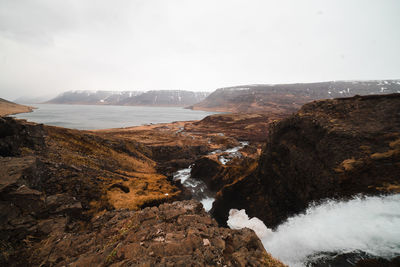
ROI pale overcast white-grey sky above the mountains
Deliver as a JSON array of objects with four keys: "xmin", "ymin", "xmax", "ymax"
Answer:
[{"xmin": 0, "ymin": 0, "xmax": 400, "ymax": 100}]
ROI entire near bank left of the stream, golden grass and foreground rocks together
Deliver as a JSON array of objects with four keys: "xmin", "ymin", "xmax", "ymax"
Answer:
[{"xmin": 0, "ymin": 118, "xmax": 283, "ymax": 266}]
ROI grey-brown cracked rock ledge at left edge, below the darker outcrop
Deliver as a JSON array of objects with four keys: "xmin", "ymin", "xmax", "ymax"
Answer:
[{"xmin": 0, "ymin": 156, "xmax": 82, "ymax": 266}]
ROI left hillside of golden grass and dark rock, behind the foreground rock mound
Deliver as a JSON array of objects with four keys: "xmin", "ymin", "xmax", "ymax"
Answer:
[{"xmin": 0, "ymin": 118, "xmax": 181, "ymax": 265}]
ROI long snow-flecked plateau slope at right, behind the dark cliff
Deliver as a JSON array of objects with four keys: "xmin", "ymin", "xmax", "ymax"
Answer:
[{"xmin": 192, "ymin": 80, "xmax": 400, "ymax": 114}]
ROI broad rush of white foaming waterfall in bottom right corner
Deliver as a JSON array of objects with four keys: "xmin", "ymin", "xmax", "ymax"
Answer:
[{"xmin": 228, "ymin": 194, "xmax": 400, "ymax": 266}]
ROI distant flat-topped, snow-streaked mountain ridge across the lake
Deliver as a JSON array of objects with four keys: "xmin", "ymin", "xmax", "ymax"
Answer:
[{"xmin": 46, "ymin": 90, "xmax": 210, "ymax": 106}]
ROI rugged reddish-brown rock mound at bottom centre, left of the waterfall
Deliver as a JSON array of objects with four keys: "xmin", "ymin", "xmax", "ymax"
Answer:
[{"xmin": 30, "ymin": 200, "xmax": 283, "ymax": 266}]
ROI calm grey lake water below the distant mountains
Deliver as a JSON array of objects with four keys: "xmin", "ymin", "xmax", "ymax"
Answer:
[{"xmin": 13, "ymin": 104, "xmax": 219, "ymax": 130}]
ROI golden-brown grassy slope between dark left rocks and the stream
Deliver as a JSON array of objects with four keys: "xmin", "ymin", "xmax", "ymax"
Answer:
[{"xmin": 47, "ymin": 127, "xmax": 180, "ymax": 213}]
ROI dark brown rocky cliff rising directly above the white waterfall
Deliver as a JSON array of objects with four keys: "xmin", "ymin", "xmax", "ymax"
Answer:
[{"xmin": 212, "ymin": 94, "xmax": 400, "ymax": 227}]
